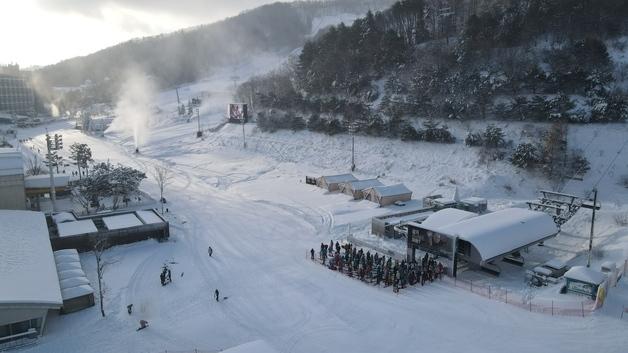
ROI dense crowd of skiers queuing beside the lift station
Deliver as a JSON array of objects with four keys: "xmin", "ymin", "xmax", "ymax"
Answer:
[{"xmin": 310, "ymin": 241, "xmax": 446, "ymax": 292}]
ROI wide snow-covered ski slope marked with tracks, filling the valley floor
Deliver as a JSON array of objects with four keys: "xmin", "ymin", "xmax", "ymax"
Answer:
[{"xmin": 14, "ymin": 60, "xmax": 628, "ymax": 353}]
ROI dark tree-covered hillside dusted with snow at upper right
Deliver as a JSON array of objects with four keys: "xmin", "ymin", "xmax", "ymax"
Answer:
[{"xmin": 238, "ymin": 0, "xmax": 628, "ymax": 133}]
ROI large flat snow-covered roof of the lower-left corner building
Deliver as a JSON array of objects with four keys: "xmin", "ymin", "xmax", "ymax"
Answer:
[{"xmin": 0, "ymin": 210, "xmax": 62, "ymax": 307}]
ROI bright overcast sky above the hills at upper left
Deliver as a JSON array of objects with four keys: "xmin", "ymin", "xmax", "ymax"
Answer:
[{"xmin": 0, "ymin": 0, "xmax": 275, "ymax": 67}]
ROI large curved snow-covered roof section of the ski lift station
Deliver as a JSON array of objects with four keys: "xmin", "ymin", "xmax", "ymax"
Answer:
[{"xmin": 439, "ymin": 208, "xmax": 559, "ymax": 261}]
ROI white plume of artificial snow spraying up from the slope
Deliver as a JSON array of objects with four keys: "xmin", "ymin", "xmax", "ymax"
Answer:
[{"xmin": 108, "ymin": 70, "xmax": 155, "ymax": 148}]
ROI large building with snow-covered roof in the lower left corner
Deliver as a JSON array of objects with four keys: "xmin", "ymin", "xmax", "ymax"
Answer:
[{"xmin": 0, "ymin": 210, "xmax": 63, "ymax": 350}]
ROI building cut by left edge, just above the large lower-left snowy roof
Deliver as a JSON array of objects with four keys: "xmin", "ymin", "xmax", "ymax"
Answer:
[{"xmin": 0, "ymin": 148, "xmax": 26, "ymax": 210}]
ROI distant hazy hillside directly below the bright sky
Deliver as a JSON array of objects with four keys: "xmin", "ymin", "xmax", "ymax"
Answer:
[{"xmin": 36, "ymin": 0, "xmax": 394, "ymax": 91}]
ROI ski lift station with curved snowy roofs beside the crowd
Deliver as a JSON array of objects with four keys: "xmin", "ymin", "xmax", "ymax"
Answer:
[{"xmin": 408, "ymin": 208, "xmax": 559, "ymax": 276}]
